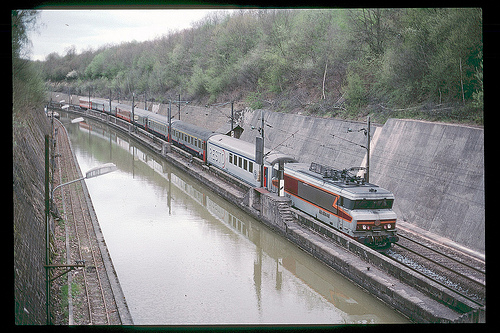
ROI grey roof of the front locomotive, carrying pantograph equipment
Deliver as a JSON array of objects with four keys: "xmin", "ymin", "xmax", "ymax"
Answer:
[{"xmin": 285, "ymin": 163, "xmax": 393, "ymax": 197}]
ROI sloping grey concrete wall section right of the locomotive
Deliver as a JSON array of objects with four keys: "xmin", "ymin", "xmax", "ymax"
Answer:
[{"xmin": 370, "ymin": 119, "xmax": 485, "ymax": 253}]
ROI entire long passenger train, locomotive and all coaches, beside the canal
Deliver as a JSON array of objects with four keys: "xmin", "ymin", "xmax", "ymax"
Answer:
[{"xmin": 79, "ymin": 94, "xmax": 398, "ymax": 250}]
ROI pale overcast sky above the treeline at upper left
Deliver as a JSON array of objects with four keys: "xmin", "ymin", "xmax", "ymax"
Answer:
[{"xmin": 29, "ymin": 9, "xmax": 230, "ymax": 60}]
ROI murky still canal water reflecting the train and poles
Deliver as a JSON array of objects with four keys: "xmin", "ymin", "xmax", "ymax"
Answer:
[{"xmin": 62, "ymin": 115, "xmax": 408, "ymax": 325}]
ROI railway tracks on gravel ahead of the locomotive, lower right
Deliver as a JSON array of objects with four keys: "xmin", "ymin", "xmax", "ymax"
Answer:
[{"xmin": 385, "ymin": 230, "xmax": 486, "ymax": 306}]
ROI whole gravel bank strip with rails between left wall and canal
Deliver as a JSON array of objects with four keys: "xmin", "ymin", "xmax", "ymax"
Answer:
[{"xmin": 51, "ymin": 120, "xmax": 133, "ymax": 325}]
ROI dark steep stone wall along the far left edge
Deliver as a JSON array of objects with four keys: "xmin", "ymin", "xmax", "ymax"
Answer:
[{"xmin": 12, "ymin": 109, "xmax": 50, "ymax": 325}]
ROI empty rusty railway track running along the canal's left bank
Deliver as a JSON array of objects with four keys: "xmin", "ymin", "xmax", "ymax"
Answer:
[{"xmin": 54, "ymin": 120, "xmax": 121, "ymax": 325}]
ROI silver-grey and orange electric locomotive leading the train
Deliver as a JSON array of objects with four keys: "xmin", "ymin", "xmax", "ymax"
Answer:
[{"xmin": 284, "ymin": 162, "xmax": 398, "ymax": 249}]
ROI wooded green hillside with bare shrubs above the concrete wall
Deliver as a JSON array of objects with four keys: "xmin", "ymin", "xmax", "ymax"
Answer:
[{"xmin": 36, "ymin": 8, "xmax": 483, "ymax": 124}]
